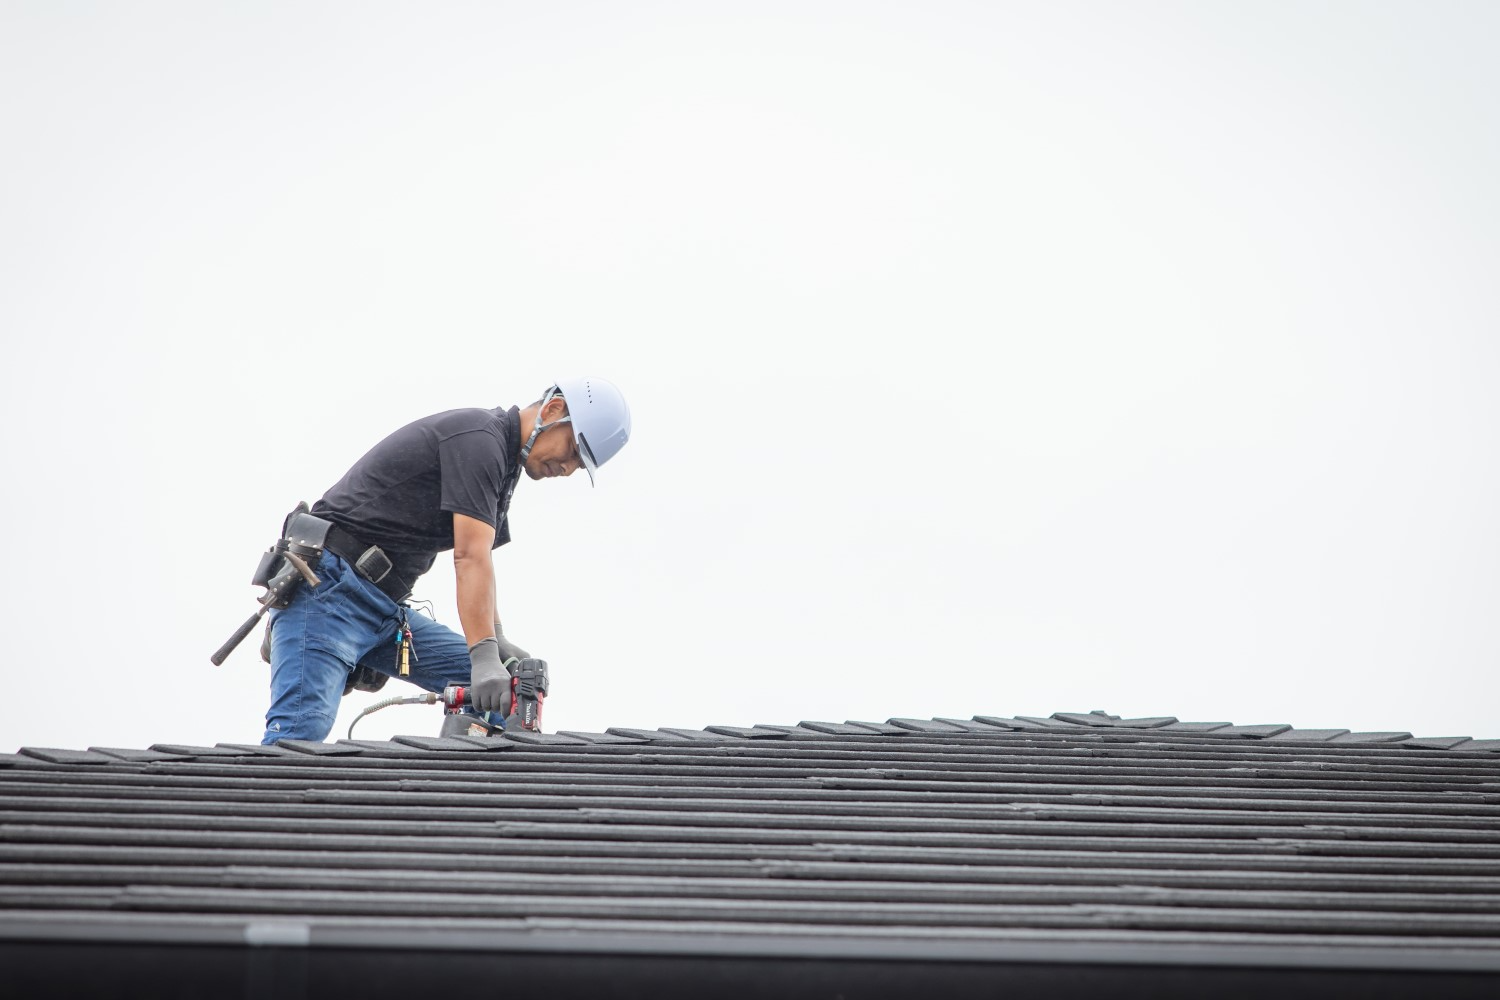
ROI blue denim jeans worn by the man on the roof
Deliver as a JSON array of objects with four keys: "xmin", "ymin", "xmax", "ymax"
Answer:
[{"xmin": 261, "ymin": 552, "xmax": 470, "ymax": 744}]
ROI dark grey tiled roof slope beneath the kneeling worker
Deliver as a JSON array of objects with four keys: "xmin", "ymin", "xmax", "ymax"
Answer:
[{"xmin": 0, "ymin": 712, "xmax": 1500, "ymax": 996}]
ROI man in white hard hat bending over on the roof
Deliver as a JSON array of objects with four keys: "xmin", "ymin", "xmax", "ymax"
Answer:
[{"xmin": 261, "ymin": 378, "xmax": 630, "ymax": 744}]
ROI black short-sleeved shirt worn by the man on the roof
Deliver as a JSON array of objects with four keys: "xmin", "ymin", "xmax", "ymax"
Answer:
[{"xmin": 312, "ymin": 406, "xmax": 521, "ymax": 583}]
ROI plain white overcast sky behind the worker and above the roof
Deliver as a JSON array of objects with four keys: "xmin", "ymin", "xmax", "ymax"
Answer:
[{"xmin": 0, "ymin": 0, "xmax": 1500, "ymax": 750}]
